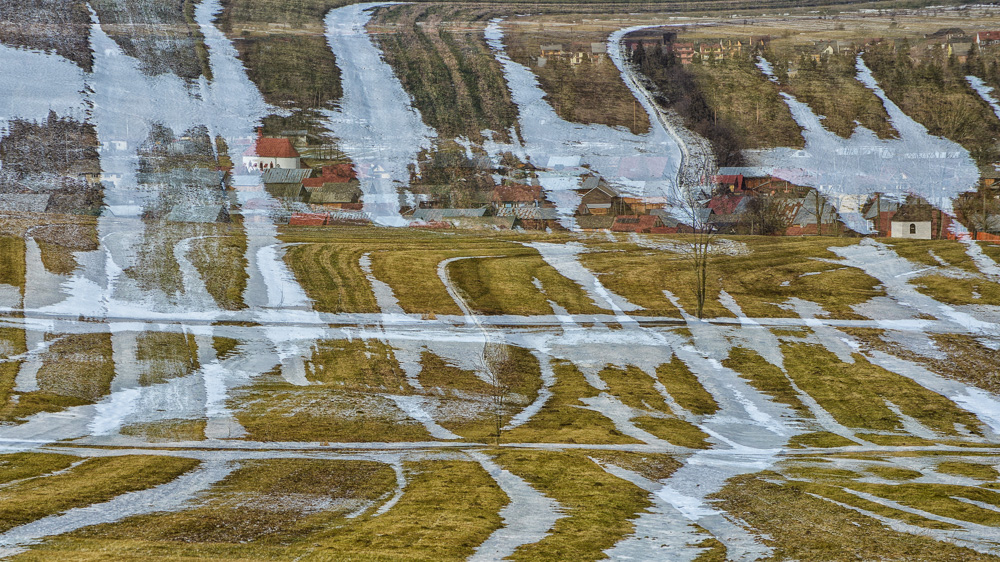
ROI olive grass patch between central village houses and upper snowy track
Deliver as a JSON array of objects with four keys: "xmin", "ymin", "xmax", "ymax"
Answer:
[{"xmin": 282, "ymin": 227, "xmax": 601, "ymax": 314}]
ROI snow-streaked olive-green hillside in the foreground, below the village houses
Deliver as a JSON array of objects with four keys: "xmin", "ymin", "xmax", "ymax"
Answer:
[{"xmin": 0, "ymin": 222, "xmax": 1000, "ymax": 559}]
